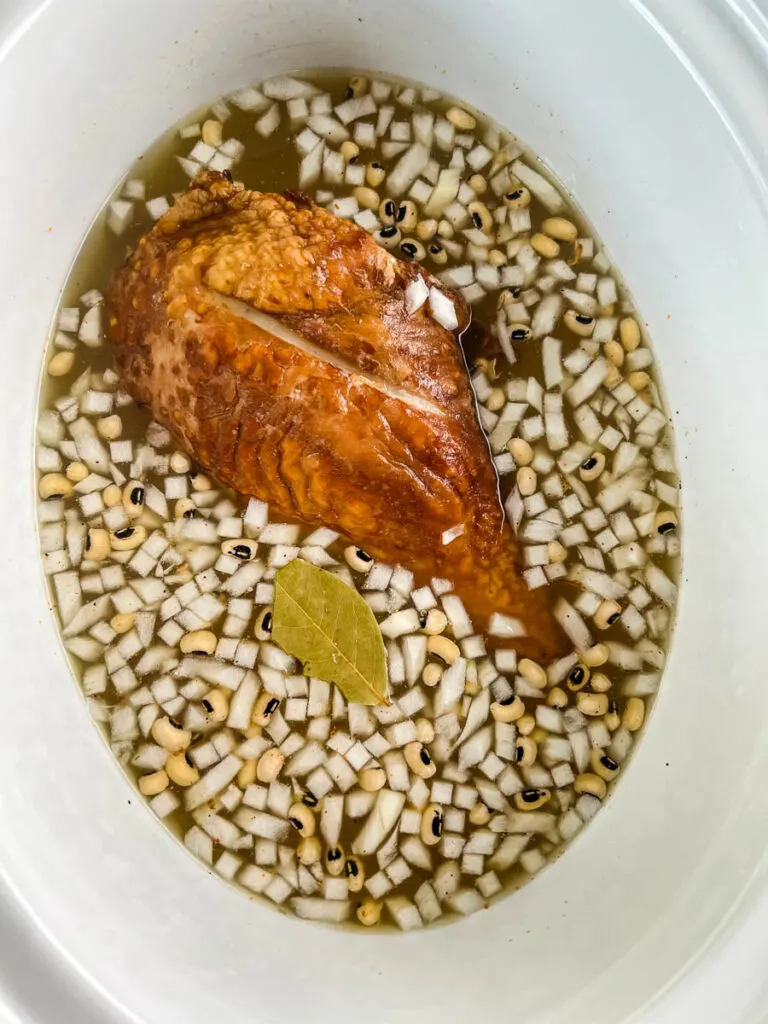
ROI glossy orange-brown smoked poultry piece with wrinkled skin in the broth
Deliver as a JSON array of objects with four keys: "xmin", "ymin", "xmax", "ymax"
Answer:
[{"xmin": 109, "ymin": 172, "xmax": 560, "ymax": 656}]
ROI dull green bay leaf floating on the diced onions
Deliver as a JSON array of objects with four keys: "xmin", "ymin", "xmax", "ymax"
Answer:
[{"xmin": 272, "ymin": 558, "xmax": 389, "ymax": 706}]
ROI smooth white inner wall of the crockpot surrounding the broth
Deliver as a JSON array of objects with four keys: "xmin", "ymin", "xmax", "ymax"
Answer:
[{"xmin": 0, "ymin": 0, "xmax": 768, "ymax": 1024}]
